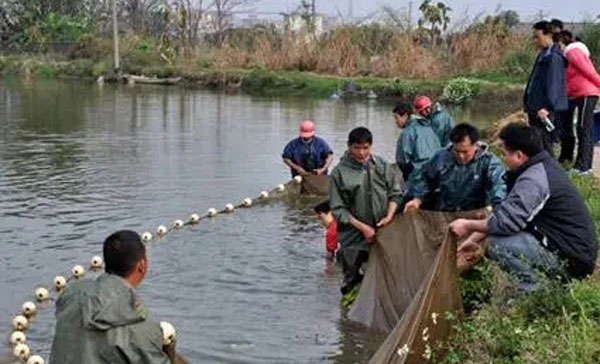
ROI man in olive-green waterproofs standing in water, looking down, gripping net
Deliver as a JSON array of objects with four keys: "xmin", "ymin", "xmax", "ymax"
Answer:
[{"xmin": 329, "ymin": 127, "xmax": 402, "ymax": 294}]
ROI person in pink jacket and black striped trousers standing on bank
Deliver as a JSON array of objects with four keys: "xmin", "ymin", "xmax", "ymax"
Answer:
[{"xmin": 559, "ymin": 30, "xmax": 600, "ymax": 174}]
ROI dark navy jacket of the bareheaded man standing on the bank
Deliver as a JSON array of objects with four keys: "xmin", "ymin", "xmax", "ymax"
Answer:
[{"xmin": 523, "ymin": 43, "xmax": 569, "ymax": 113}]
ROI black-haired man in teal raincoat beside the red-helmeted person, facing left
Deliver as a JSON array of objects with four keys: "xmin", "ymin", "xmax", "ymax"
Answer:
[{"xmin": 394, "ymin": 104, "xmax": 441, "ymax": 197}]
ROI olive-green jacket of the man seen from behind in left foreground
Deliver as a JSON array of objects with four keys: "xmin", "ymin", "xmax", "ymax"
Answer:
[{"xmin": 50, "ymin": 274, "xmax": 169, "ymax": 364}]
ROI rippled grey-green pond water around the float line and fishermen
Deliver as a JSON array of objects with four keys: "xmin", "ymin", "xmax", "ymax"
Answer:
[{"xmin": 0, "ymin": 80, "xmax": 518, "ymax": 363}]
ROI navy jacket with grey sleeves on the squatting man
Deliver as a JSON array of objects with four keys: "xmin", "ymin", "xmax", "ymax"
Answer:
[{"xmin": 488, "ymin": 152, "xmax": 598, "ymax": 278}]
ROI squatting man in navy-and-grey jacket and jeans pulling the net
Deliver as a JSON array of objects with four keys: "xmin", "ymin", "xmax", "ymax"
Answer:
[{"xmin": 450, "ymin": 124, "xmax": 598, "ymax": 292}]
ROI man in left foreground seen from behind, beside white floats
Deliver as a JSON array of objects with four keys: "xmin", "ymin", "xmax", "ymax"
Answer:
[{"xmin": 50, "ymin": 231, "xmax": 184, "ymax": 364}]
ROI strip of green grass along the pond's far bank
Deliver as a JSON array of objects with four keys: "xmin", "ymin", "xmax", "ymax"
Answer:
[{"xmin": 0, "ymin": 55, "xmax": 523, "ymax": 102}]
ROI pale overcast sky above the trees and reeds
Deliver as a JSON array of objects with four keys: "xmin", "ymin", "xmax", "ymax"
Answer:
[{"xmin": 254, "ymin": 0, "xmax": 600, "ymax": 21}]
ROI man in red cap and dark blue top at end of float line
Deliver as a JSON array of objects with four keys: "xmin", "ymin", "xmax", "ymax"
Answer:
[{"xmin": 282, "ymin": 120, "xmax": 333, "ymax": 177}]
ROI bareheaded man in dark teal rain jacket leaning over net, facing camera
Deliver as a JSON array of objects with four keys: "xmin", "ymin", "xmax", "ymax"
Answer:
[{"xmin": 404, "ymin": 124, "xmax": 506, "ymax": 212}]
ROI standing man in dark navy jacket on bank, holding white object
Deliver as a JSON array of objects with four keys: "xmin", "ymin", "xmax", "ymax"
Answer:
[{"xmin": 523, "ymin": 21, "xmax": 569, "ymax": 155}]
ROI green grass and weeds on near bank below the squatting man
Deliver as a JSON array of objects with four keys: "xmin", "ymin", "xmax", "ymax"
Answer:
[{"xmin": 448, "ymin": 177, "xmax": 600, "ymax": 364}]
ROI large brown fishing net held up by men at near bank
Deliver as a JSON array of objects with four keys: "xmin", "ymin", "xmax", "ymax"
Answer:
[{"xmin": 348, "ymin": 211, "xmax": 490, "ymax": 364}]
